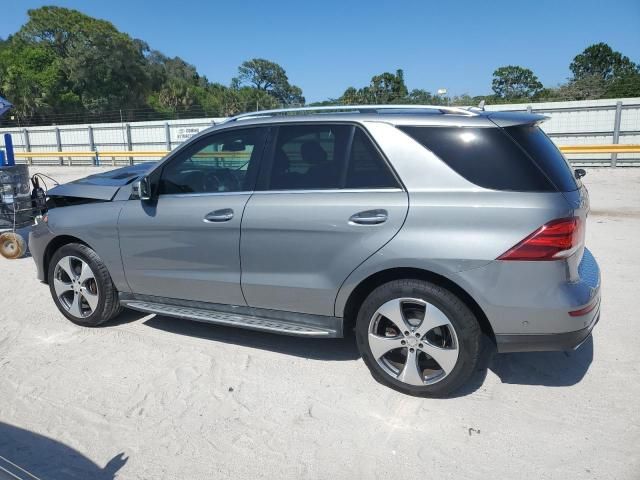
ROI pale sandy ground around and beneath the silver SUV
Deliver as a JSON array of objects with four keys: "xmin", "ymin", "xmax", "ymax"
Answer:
[{"xmin": 0, "ymin": 167, "xmax": 640, "ymax": 480}]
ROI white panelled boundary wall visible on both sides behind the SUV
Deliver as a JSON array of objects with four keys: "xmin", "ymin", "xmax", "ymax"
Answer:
[{"xmin": 0, "ymin": 98, "xmax": 640, "ymax": 166}]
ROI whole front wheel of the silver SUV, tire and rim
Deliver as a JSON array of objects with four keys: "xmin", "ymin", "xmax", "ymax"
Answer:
[{"xmin": 48, "ymin": 243, "xmax": 120, "ymax": 327}]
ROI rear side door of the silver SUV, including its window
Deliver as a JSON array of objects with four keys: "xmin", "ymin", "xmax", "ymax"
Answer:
[{"xmin": 240, "ymin": 123, "xmax": 408, "ymax": 315}]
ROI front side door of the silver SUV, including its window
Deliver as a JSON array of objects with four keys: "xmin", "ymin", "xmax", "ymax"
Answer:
[{"xmin": 118, "ymin": 128, "xmax": 266, "ymax": 305}]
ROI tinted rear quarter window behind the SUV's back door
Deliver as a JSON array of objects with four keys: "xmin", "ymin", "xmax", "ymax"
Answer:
[{"xmin": 399, "ymin": 127, "xmax": 554, "ymax": 192}]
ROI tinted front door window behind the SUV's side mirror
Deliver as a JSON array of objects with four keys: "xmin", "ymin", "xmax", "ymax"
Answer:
[{"xmin": 160, "ymin": 128, "xmax": 263, "ymax": 194}]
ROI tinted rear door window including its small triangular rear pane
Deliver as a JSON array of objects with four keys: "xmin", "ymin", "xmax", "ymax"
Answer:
[{"xmin": 269, "ymin": 125, "xmax": 397, "ymax": 190}]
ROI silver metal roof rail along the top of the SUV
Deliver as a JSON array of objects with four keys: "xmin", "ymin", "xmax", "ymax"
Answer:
[{"xmin": 223, "ymin": 105, "xmax": 478, "ymax": 123}]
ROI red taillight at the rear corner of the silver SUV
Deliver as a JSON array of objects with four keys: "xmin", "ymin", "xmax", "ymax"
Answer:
[{"xmin": 498, "ymin": 217, "xmax": 584, "ymax": 260}]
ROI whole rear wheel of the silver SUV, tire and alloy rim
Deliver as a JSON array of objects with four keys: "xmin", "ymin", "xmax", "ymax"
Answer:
[{"xmin": 356, "ymin": 280, "xmax": 481, "ymax": 397}]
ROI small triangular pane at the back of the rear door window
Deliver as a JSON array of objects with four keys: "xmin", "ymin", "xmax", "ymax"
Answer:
[{"xmin": 345, "ymin": 128, "xmax": 398, "ymax": 188}]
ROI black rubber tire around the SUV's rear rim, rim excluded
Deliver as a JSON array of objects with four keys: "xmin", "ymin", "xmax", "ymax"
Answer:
[{"xmin": 355, "ymin": 279, "xmax": 482, "ymax": 397}]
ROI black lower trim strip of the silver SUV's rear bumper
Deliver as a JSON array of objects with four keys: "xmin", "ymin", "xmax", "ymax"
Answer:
[{"xmin": 496, "ymin": 305, "xmax": 600, "ymax": 353}]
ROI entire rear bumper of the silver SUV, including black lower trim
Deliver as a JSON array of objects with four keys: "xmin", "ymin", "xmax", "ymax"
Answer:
[{"xmin": 458, "ymin": 248, "xmax": 600, "ymax": 352}]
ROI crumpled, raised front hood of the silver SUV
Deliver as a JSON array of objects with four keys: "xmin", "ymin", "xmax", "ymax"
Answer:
[{"xmin": 47, "ymin": 162, "xmax": 157, "ymax": 201}]
